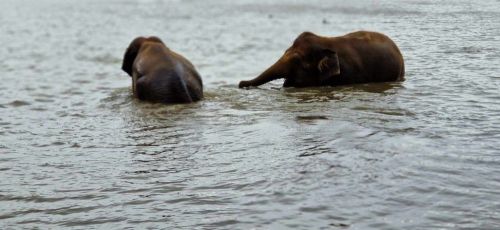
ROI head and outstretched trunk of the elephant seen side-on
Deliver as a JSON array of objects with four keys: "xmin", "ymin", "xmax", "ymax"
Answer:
[{"xmin": 239, "ymin": 32, "xmax": 341, "ymax": 88}]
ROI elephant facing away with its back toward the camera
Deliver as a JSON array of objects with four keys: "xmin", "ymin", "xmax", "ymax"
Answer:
[{"xmin": 122, "ymin": 36, "xmax": 203, "ymax": 104}]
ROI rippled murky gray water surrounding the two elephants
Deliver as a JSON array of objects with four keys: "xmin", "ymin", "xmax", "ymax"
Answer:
[{"xmin": 0, "ymin": 0, "xmax": 500, "ymax": 229}]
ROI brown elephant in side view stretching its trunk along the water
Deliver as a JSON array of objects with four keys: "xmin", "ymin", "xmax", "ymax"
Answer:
[{"xmin": 239, "ymin": 31, "xmax": 405, "ymax": 88}]
